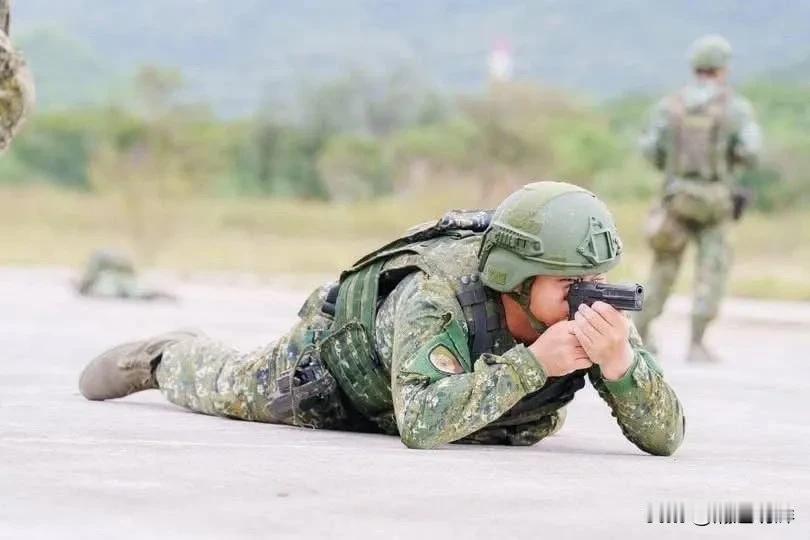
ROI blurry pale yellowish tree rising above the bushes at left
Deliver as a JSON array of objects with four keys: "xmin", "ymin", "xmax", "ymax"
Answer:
[{"xmin": 90, "ymin": 66, "xmax": 224, "ymax": 262}]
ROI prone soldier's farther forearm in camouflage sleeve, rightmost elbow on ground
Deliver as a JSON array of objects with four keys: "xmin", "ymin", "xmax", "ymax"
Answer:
[{"xmin": 588, "ymin": 324, "xmax": 686, "ymax": 456}]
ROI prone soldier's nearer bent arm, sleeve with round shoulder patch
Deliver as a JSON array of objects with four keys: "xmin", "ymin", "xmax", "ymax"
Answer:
[{"xmin": 391, "ymin": 274, "xmax": 546, "ymax": 448}]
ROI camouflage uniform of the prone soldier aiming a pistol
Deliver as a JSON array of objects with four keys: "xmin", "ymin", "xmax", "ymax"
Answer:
[{"xmin": 156, "ymin": 235, "xmax": 684, "ymax": 455}]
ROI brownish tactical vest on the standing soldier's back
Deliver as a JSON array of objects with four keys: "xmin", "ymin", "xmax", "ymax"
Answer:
[{"xmin": 666, "ymin": 88, "xmax": 731, "ymax": 181}]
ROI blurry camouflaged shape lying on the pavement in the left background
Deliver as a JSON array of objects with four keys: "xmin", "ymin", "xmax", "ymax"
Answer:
[{"xmin": 76, "ymin": 250, "xmax": 173, "ymax": 300}]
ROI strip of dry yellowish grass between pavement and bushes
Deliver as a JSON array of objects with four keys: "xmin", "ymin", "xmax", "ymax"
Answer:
[{"xmin": 6, "ymin": 187, "xmax": 810, "ymax": 300}]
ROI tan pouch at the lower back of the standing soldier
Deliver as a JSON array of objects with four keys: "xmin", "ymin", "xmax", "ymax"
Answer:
[{"xmin": 664, "ymin": 178, "xmax": 733, "ymax": 225}]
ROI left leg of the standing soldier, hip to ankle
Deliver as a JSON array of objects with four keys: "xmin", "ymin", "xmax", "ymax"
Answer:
[{"xmin": 633, "ymin": 208, "xmax": 689, "ymax": 348}]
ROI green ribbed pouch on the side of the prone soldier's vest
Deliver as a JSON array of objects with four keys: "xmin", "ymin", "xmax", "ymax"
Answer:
[{"xmin": 318, "ymin": 319, "xmax": 393, "ymax": 417}]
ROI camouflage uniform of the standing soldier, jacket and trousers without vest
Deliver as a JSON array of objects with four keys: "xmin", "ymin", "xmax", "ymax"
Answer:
[{"xmin": 634, "ymin": 82, "xmax": 762, "ymax": 343}]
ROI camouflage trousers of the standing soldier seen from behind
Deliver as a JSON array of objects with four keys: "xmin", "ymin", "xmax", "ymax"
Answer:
[{"xmin": 634, "ymin": 209, "xmax": 732, "ymax": 342}]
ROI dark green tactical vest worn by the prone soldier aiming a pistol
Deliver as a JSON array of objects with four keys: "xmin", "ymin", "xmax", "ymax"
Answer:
[{"xmin": 319, "ymin": 212, "xmax": 586, "ymax": 425}]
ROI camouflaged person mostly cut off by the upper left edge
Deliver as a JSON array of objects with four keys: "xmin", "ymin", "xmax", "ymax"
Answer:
[{"xmin": 0, "ymin": 0, "xmax": 34, "ymax": 151}]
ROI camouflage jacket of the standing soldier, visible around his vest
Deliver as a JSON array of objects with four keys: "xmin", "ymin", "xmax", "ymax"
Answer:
[{"xmin": 639, "ymin": 83, "xmax": 762, "ymax": 176}]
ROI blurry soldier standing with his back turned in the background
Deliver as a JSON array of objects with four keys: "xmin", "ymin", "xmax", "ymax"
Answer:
[{"xmin": 635, "ymin": 35, "xmax": 761, "ymax": 362}]
